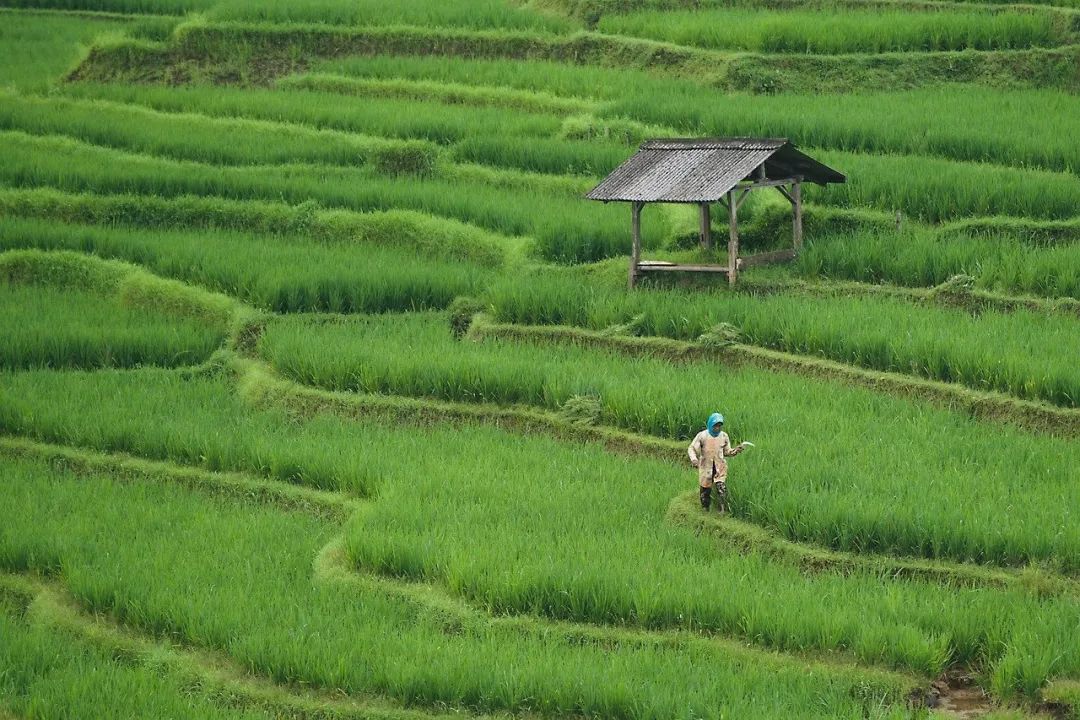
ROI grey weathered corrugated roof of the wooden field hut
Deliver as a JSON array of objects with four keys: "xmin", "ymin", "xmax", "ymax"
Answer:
[{"xmin": 585, "ymin": 137, "xmax": 846, "ymax": 203}]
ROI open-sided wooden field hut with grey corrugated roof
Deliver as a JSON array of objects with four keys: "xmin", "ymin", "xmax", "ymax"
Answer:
[{"xmin": 585, "ymin": 137, "xmax": 846, "ymax": 288}]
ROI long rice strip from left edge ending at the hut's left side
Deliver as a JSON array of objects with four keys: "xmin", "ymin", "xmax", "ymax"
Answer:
[{"xmin": 0, "ymin": 132, "xmax": 665, "ymax": 261}]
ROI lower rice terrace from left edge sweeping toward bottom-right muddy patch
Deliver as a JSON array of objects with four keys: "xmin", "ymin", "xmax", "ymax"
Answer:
[{"xmin": 0, "ymin": 446, "xmax": 928, "ymax": 718}]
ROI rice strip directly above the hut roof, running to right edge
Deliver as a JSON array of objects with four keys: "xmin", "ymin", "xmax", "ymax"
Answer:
[{"xmin": 603, "ymin": 82, "xmax": 1080, "ymax": 171}]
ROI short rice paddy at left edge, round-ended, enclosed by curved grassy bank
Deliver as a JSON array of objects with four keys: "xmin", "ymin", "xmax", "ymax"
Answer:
[{"xmin": 0, "ymin": 280, "xmax": 225, "ymax": 368}]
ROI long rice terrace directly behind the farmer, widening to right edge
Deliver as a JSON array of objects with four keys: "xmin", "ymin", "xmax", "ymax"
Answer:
[{"xmin": 260, "ymin": 315, "xmax": 1080, "ymax": 572}]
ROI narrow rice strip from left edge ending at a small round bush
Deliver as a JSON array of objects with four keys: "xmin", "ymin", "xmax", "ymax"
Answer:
[{"xmin": 0, "ymin": 94, "xmax": 437, "ymax": 174}]
